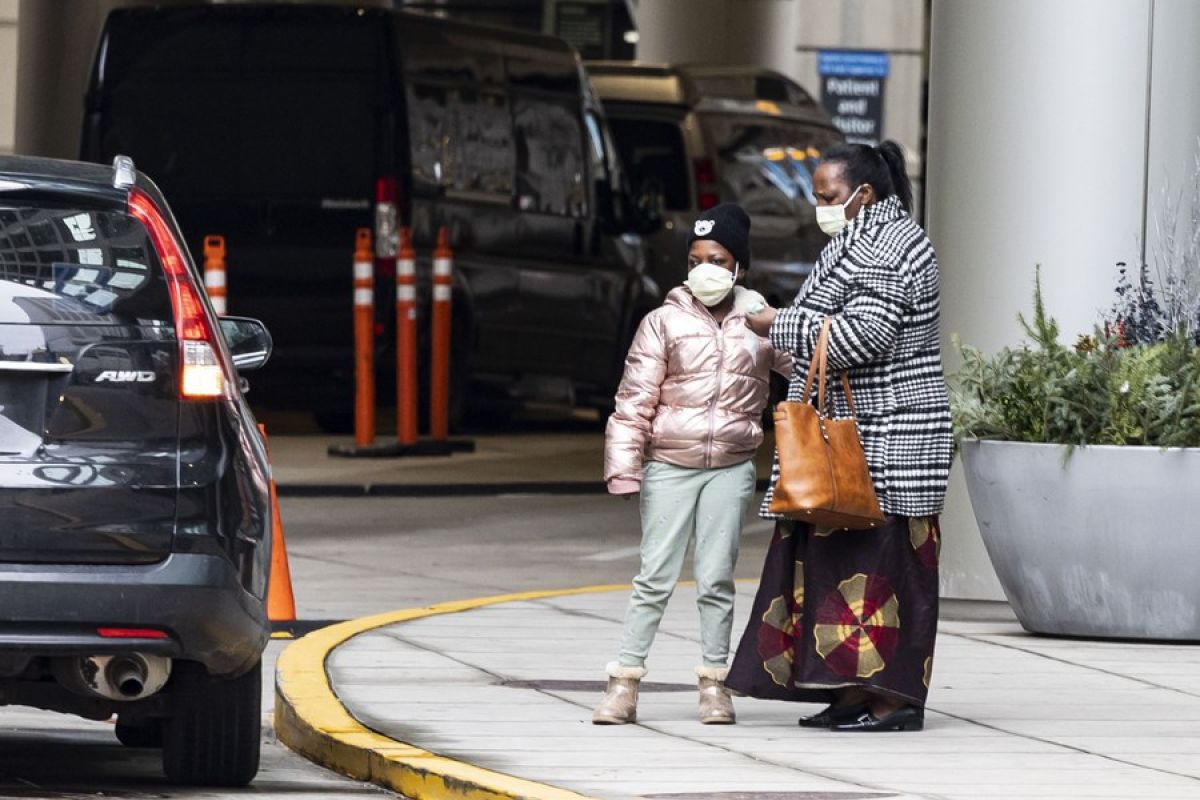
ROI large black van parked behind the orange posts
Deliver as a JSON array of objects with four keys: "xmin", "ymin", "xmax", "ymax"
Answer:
[{"xmin": 83, "ymin": 4, "xmax": 661, "ymax": 422}]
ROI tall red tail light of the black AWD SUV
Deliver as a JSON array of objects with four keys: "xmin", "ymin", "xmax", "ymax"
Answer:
[{"xmin": 130, "ymin": 188, "xmax": 232, "ymax": 399}]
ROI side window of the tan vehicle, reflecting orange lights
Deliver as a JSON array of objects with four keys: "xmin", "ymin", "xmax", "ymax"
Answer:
[{"xmin": 701, "ymin": 114, "xmax": 841, "ymax": 217}]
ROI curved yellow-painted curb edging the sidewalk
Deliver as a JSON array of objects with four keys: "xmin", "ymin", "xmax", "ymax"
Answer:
[{"xmin": 275, "ymin": 584, "xmax": 629, "ymax": 800}]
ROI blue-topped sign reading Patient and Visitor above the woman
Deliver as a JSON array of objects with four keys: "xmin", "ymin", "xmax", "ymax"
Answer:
[{"xmin": 817, "ymin": 50, "xmax": 890, "ymax": 145}]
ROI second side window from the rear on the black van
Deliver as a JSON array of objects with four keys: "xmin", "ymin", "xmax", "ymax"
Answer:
[{"xmin": 512, "ymin": 91, "xmax": 588, "ymax": 217}]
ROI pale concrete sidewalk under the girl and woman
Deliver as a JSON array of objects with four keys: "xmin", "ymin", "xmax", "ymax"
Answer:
[{"xmin": 280, "ymin": 584, "xmax": 1200, "ymax": 800}]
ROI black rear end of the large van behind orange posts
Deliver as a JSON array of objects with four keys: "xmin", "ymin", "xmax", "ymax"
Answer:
[{"xmin": 83, "ymin": 4, "xmax": 388, "ymax": 409}]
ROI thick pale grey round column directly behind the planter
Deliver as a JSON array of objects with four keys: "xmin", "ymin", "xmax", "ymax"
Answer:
[{"xmin": 926, "ymin": 0, "xmax": 1200, "ymax": 597}]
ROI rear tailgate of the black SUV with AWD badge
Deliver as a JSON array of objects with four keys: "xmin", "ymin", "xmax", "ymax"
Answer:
[{"xmin": 0, "ymin": 203, "xmax": 179, "ymax": 564}]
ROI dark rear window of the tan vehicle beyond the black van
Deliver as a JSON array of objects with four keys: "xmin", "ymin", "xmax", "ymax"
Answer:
[{"xmin": 608, "ymin": 119, "xmax": 691, "ymax": 211}]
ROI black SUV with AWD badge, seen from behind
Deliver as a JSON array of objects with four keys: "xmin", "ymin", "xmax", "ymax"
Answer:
[{"xmin": 0, "ymin": 156, "xmax": 272, "ymax": 786}]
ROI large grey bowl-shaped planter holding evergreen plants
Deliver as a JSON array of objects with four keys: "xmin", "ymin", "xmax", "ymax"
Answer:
[{"xmin": 961, "ymin": 441, "xmax": 1200, "ymax": 640}]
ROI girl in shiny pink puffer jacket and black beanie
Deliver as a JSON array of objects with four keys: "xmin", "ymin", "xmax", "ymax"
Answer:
[{"xmin": 592, "ymin": 203, "xmax": 792, "ymax": 724}]
